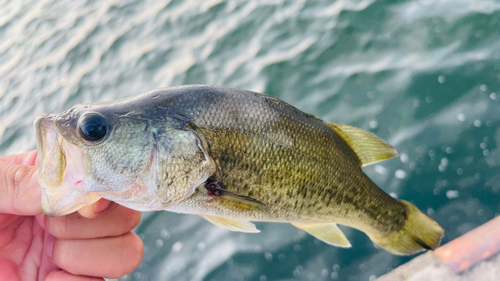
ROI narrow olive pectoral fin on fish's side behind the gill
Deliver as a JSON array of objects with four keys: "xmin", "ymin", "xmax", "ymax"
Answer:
[{"xmin": 208, "ymin": 189, "xmax": 271, "ymax": 215}]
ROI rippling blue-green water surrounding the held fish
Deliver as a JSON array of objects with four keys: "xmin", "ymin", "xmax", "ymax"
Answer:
[{"xmin": 0, "ymin": 0, "xmax": 500, "ymax": 281}]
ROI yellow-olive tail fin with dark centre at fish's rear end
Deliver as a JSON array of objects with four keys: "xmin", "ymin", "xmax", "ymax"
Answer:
[{"xmin": 370, "ymin": 200, "xmax": 444, "ymax": 255}]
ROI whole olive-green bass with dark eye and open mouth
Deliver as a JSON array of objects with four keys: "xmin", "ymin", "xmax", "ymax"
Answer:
[{"xmin": 34, "ymin": 85, "xmax": 444, "ymax": 255}]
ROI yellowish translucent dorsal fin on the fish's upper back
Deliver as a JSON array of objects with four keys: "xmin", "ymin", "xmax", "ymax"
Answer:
[{"xmin": 325, "ymin": 122, "xmax": 398, "ymax": 167}]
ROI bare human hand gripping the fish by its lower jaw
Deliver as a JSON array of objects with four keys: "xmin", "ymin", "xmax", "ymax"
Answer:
[{"xmin": 0, "ymin": 151, "xmax": 144, "ymax": 281}]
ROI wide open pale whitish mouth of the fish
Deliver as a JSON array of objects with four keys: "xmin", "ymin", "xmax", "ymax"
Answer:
[{"xmin": 34, "ymin": 114, "xmax": 100, "ymax": 216}]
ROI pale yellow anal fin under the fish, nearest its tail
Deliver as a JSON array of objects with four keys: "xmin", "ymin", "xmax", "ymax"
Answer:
[{"xmin": 292, "ymin": 223, "xmax": 351, "ymax": 248}]
